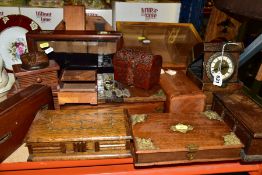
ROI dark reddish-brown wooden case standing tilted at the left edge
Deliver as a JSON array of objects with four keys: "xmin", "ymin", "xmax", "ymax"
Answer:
[{"xmin": 0, "ymin": 85, "xmax": 54, "ymax": 161}]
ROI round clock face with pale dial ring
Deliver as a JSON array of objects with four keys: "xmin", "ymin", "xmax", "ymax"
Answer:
[{"xmin": 206, "ymin": 52, "xmax": 235, "ymax": 81}]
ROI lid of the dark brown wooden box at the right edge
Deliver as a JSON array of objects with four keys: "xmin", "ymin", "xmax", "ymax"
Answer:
[{"xmin": 214, "ymin": 92, "xmax": 262, "ymax": 138}]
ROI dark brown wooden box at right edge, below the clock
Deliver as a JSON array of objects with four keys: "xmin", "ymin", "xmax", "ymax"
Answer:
[{"xmin": 212, "ymin": 92, "xmax": 262, "ymax": 162}]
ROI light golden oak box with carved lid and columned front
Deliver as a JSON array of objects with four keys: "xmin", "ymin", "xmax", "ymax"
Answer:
[{"xmin": 25, "ymin": 109, "xmax": 131, "ymax": 161}]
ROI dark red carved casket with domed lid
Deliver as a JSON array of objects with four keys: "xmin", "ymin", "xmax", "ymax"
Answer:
[{"xmin": 113, "ymin": 48, "xmax": 162, "ymax": 89}]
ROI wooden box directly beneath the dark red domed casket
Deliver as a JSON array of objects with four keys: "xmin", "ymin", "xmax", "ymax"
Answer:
[{"xmin": 61, "ymin": 73, "xmax": 166, "ymax": 114}]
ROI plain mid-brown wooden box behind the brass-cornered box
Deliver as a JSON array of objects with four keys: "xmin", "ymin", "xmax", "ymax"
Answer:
[{"xmin": 160, "ymin": 71, "xmax": 206, "ymax": 113}]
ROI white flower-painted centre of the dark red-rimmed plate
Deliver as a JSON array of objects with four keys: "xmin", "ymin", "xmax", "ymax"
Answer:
[{"xmin": 0, "ymin": 26, "xmax": 28, "ymax": 70}]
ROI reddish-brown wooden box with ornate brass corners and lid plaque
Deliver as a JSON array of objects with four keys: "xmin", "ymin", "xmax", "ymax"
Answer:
[{"xmin": 130, "ymin": 113, "xmax": 243, "ymax": 166}]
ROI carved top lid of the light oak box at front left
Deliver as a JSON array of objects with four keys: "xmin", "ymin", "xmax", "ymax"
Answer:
[{"xmin": 26, "ymin": 109, "xmax": 131, "ymax": 143}]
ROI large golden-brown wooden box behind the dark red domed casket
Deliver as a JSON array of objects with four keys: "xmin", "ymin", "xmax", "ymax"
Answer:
[{"xmin": 117, "ymin": 22, "xmax": 202, "ymax": 69}]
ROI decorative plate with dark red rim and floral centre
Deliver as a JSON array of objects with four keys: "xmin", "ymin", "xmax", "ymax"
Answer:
[{"xmin": 0, "ymin": 15, "xmax": 41, "ymax": 70}]
